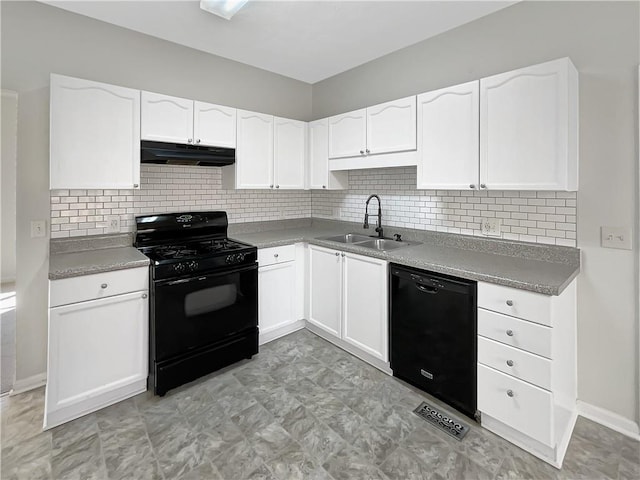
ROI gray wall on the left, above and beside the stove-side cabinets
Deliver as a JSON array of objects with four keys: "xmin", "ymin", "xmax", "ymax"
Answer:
[{"xmin": 0, "ymin": 1, "xmax": 311, "ymax": 384}]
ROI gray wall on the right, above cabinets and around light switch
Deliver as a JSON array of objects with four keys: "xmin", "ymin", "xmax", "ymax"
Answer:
[{"xmin": 313, "ymin": 1, "xmax": 640, "ymax": 422}]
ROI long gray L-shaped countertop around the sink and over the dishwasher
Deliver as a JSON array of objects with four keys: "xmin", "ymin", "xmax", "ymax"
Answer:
[{"xmin": 229, "ymin": 219, "xmax": 580, "ymax": 295}]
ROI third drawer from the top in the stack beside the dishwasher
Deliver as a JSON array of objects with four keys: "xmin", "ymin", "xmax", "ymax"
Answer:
[{"xmin": 478, "ymin": 337, "xmax": 551, "ymax": 390}]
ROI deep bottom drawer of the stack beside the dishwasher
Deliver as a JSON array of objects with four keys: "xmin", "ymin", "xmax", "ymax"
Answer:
[{"xmin": 478, "ymin": 365, "xmax": 553, "ymax": 446}]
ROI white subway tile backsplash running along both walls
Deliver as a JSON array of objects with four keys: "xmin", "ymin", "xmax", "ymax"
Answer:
[{"xmin": 51, "ymin": 165, "xmax": 577, "ymax": 247}]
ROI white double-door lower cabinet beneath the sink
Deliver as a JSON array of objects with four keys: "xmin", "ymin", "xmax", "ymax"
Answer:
[{"xmin": 308, "ymin": 245, "xmax": 389, "ymax": 362}]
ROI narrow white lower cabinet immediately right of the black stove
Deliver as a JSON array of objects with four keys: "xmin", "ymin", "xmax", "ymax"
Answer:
[{"xmin": 258, "ymin": 244, "xmax": 304, "ymax": 344}]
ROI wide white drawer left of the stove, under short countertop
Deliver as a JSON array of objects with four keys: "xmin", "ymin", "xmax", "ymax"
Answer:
[{"xmin": 49, "ymin": 267, "xmax": 149, "ymax": 307}]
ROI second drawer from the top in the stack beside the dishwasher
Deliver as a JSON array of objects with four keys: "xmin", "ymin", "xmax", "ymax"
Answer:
[{"xmin": 478, "ymin": 308, "xmax": 552, "ymax": 358}]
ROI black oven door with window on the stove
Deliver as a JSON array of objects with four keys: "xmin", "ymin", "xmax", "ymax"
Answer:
[{"xmin": 151, "ymin": 264, "xmax": 258, "ymax": 362}]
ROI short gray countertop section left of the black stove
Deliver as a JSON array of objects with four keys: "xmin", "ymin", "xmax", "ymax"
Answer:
[{"xmin": 49, "ymin": 236, "xmax": 149, "ymax": 280}]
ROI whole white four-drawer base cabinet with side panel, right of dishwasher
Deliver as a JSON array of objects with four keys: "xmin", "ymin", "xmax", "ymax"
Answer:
[{"xmin": 478, "ymin": 281, "xmax": 577, "ymax": 468}]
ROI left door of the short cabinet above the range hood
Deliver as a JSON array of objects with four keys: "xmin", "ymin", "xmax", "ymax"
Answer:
[{"xmin": 140, "ymin": 92, "xmax": 193, "ymax": 143}]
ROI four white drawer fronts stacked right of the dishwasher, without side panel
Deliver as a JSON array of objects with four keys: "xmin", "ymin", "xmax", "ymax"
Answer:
[{"xmin": 478, "ymin": 282, "xmax": 553, "ymax": 445}]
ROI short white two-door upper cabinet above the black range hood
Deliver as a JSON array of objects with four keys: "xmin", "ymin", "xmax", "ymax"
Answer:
[{"xmin": 141, "ymin": 92, "xmax": 236, "ymax": 148}]
